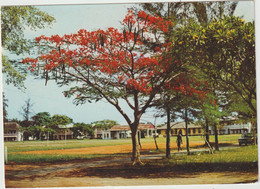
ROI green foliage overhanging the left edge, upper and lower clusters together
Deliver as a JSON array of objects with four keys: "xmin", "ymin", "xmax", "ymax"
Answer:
[{"xmin": 1, "ymin": 6, "xmax": 55, "ymax": 89}]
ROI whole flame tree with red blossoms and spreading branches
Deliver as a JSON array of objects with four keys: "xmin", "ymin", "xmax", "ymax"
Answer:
[{"xmin": 23, "ymin": 11, "xmax": 204, "ymax": 164}]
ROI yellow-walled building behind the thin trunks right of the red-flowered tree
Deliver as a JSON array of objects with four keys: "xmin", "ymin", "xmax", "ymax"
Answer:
[{"xmin": 157, "ymin": 122, "xmax": 203, "ymax": 136}]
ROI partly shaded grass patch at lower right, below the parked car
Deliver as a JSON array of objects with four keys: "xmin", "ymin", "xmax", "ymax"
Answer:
[{"xmin": 145, "ymin": 145, "xmax": 258, "ymax": 174}]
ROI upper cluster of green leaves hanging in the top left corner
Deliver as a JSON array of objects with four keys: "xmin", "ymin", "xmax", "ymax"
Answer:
[{"xmin": 1, "ymin": 6, "xmax": 55, "ymax": 55}]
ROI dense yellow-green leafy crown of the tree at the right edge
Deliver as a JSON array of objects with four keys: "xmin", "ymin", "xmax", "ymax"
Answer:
[{"xmin": 175, "ymin": 16, "xmax": 256, "ymax": 117}]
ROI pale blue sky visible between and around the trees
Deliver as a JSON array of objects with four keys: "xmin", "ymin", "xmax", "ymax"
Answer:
[{"xmin": 0, "ymin": 1, "xmax": 254, "ymax": 125}]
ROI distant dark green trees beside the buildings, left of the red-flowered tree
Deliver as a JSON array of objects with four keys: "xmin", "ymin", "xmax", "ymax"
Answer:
[{"xmin": 4, "ymin": 98, "xmax": 118, "ymax": 140}]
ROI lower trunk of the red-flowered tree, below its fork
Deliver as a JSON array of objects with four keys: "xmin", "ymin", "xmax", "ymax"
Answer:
[{"xmin": 132, "ymin": 129, "xmax": 143, "ymax": 165}]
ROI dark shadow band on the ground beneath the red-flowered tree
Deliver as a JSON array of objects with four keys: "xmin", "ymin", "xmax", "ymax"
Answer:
[{"xmin": 69, "ymin": 162, "xmax": 258, "ymax": 179}]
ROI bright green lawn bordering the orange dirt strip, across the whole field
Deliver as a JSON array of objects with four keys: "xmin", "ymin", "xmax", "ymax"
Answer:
[{"xmin": 4, "ymin": 135, "xmax": 252, "ymax": 163}]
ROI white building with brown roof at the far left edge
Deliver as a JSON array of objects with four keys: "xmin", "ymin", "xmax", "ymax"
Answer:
[{"xmin": 4, "ymin": 122, "xmax": 23, "ymax": 141}]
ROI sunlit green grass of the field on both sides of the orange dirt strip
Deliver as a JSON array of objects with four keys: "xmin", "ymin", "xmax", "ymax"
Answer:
[{"xmin": 5, "ymin": 135, "xmax": 252, "ymax": 162}]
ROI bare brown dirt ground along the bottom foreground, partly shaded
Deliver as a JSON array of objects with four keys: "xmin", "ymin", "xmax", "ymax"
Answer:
[{"xmin": 6, "ymin": 162, "xmax": 258, "ymax": 188}]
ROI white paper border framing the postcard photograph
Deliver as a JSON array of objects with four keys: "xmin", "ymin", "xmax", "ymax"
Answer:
[{"xmin": 0, "ymin": 0, "xmax": 260, "ymax": 189}]
